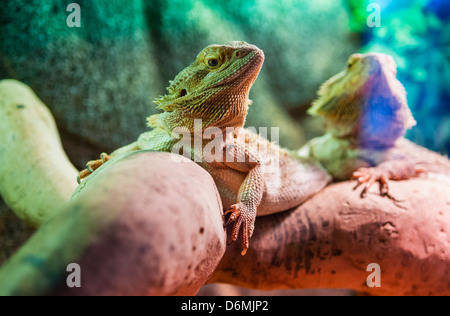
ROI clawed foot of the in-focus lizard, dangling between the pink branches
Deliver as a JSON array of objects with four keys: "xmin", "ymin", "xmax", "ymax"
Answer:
[{"xmin": 224, "ymin": 203, "xmax": 256, "ymax": 256}]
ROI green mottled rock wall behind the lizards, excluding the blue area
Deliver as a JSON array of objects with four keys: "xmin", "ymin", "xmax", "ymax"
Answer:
[{"xmin": 0, "ymin": 0, "xmax": 360, "ymax": 167}]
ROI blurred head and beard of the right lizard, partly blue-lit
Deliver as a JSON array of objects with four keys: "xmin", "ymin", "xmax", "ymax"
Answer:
[{"xmin": 308, "ymin": 53, "xmax": 416, "ymax": 148}]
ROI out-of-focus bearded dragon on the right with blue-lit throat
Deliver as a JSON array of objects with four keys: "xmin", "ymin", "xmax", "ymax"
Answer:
[{"xmin": 298, "ymin": 53, "xmax": 450, "ymax": 200}]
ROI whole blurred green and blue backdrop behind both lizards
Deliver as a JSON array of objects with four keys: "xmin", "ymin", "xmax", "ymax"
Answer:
[{"xmin": 0, "ymin": 0, "xmax": 450, "ymax": 168}]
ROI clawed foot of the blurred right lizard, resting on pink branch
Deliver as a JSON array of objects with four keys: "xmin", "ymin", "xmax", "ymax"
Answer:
[{"xmin": 351, "ymin": 167, "xmax": 396, "ymax": 200}]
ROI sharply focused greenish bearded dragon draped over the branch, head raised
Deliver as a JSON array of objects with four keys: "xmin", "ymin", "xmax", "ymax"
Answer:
[{"xmin": 79, "ymin": 42, "xmax": 331, "ymax": 255}]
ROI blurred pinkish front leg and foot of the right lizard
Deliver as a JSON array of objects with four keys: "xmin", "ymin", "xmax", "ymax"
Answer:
[{"xmin": 351, "ymin": 160, "xmax": 426, "ymax": 200}]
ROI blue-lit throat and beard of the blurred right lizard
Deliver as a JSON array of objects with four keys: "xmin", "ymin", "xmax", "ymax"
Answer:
[{"xmin": 325, "ymin": 75, "xmax": 412, "ymax": 149}]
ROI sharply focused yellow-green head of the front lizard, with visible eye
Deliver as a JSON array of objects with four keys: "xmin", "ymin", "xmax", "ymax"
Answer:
[{"xmin": 148, "ymin": 42, "xmax": 264, "ymax": 131}]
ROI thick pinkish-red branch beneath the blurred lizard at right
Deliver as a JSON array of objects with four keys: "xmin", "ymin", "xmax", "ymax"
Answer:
[{"xmin": 210, "ymin": 179, "xmax": 450, "ymax": 295}]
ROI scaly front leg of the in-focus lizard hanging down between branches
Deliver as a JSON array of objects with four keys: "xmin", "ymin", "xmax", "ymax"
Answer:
[{"xmin": 224, "ymin": 142, "xmax": 264, "ymax": 255}]
